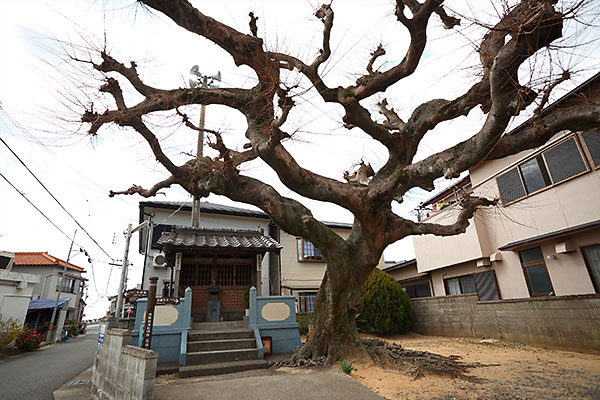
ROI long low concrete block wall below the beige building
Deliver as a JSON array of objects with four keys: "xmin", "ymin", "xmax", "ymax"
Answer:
[{"xmin": 411, "ymin": 294, "xmax": 600, "ymax": 354}]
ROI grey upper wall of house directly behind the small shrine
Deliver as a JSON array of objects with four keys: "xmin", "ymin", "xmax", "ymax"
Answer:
[{"xmin": 142, "ymin": 207, "xmax": 271, "ymax": 293}]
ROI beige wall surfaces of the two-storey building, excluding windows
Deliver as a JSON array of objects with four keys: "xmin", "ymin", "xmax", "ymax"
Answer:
[{"xmin": 413, "ymin": 130, "xmax": 600, "ymax": 299}]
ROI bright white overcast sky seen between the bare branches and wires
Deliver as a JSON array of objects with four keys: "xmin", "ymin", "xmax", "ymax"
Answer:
[{"xmin": 0, "ymin": 0, "xmax": 600, "ymax": 317}]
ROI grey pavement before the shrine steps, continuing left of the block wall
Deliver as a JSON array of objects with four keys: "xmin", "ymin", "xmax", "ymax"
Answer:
[{"xmin": 54, "ymin": 368, "xmax": 382, "ymax": 400}]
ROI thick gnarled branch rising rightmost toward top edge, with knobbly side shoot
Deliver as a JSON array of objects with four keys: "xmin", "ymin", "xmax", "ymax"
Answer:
[{"xmin": 376, "ymin": 0, "xmax": 562, "ymax": 198}]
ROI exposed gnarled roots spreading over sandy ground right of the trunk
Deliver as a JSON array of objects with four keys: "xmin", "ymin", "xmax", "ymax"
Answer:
[{"xmin": 363, "ymin": 339, "xmax": 497, "ymax": 382}]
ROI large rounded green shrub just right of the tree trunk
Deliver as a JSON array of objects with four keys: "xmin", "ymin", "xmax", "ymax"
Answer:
[{"xmin": 356, "ymin": 268, "xmax": 412, "ymax": 334}]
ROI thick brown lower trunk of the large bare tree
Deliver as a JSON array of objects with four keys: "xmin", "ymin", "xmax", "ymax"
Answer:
[{"xmin": 295, "ymin": 253, "xmax": 373, "ymax": 363}]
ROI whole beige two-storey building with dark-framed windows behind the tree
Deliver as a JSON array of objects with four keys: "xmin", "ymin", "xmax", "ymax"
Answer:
[{"xmin": 408, "ymin": 74, "xmax": 600, "ymax": 300}]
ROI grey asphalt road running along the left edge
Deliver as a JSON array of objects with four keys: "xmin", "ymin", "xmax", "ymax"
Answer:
[{"xmin": 0, "ymin": 325, "xmax": 98, "ymax": 400}]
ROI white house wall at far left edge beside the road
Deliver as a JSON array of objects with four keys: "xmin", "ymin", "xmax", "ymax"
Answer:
[{"xmin": 0, "ymin": 269, "xmax": 39, "ymax": 323}]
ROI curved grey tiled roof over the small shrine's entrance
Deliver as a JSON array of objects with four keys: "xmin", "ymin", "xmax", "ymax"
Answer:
[{"xmin": 158, "ymin": 227, "xmax": 282, "ymax": 251}]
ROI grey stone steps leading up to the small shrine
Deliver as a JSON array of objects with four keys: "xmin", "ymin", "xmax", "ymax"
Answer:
[{"xmin": 179, "ymin": 321, "xmax": 268, "ymax": 378}]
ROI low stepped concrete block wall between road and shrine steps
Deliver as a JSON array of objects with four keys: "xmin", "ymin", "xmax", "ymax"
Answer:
[{"xmin": 92, "ymin": 329, "xmax": 158, "ymax": 400}]
